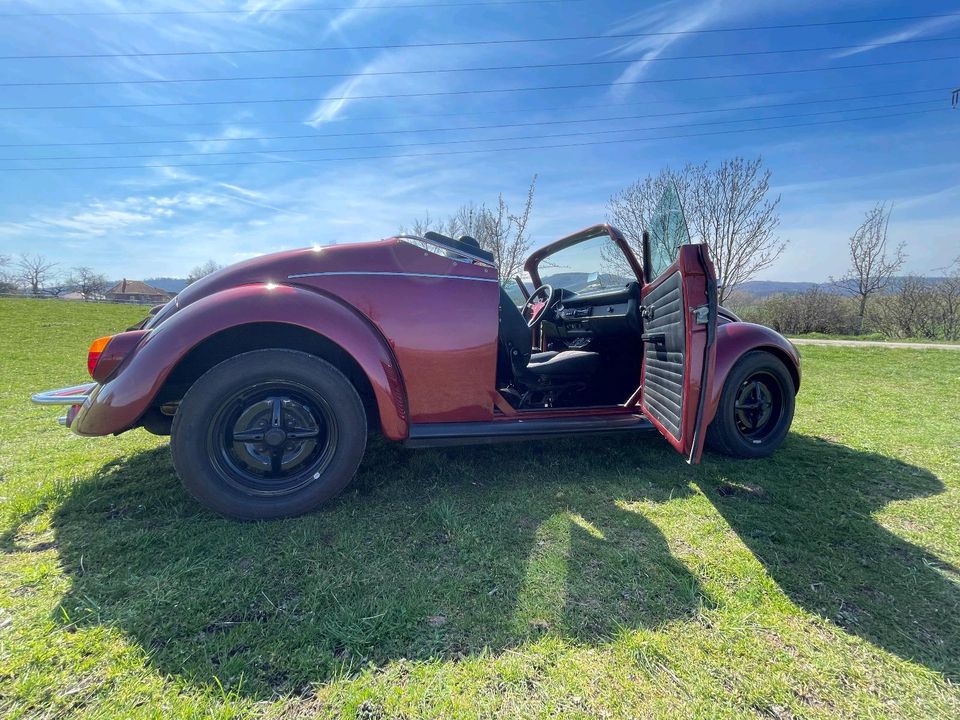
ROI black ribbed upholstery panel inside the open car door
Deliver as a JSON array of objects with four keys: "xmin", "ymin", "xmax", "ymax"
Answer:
[{"xmin": 643, "ymin": 271, "xmax": 686, "ymax": 440}]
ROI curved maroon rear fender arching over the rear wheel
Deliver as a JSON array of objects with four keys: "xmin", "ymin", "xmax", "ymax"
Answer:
[{"xmin": 71, "ymin": 283, "xmax": 408, "ymax": 440}]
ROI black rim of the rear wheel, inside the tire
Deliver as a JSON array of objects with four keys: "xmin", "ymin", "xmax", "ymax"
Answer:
[{"xmin": 207, "ymin": 381, "xmax": 337, "ymax": 497}]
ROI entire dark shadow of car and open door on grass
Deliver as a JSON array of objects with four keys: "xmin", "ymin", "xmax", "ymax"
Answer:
[{"xmin": 41, "ymin": 437, "xmax": 960, "ymax": 698}]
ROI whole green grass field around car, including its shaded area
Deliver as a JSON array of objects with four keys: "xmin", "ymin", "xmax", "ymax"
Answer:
[{"xmin": 0, "ymin": 300, "xmax": 960, "ymax": 718}]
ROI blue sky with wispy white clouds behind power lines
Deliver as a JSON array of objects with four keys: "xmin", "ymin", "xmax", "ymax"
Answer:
[{"xmin": 0, "ymin": 0, "xmax": 960, "ymax": 280}]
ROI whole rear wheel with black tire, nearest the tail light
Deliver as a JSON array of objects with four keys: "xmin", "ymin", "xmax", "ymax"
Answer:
[{"xmin": 170, "ymin": 349, "xmax": 367, "ymax": 520}]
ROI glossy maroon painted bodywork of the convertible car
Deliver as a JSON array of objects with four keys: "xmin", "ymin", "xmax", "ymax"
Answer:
[{"xmin": 58, "ymin": 225, "xmax": 799, "ymax": 458}]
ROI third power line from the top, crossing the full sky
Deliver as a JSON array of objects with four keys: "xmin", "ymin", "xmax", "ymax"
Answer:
[{"xmin": 0, "ymin": 36, "xmax": 960, "ymax": 87}]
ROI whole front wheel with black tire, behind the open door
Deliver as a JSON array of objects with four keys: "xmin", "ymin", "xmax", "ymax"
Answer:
[{"xmin": 707, "ymin": 350, "xmax": 796, "ymax": 458}]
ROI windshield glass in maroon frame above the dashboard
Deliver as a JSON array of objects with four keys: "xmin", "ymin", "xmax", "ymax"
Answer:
[{"xmin": 538, "ymin": 231, "xmax": 637, "ymax": 293}]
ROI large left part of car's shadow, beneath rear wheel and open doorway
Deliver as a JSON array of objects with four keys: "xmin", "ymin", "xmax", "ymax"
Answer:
[{"xmin": 45, "ymin": 439, "xmax": 709, "ymax": 698}]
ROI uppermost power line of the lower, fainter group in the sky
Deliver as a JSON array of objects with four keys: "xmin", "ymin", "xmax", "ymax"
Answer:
[{"xmin": 0, "ymin": 87, "xmax": 950, "ymax": 150}]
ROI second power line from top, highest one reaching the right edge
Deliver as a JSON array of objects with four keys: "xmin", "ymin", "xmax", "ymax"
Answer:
[{"xmin": 0, "ymin": 13, "xmax": 960, "ymax": 60}]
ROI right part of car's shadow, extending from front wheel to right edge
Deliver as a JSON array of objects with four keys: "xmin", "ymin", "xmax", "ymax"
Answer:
[{"xmin": 697, "ymin": 435, "xmax": 960, "ymax": 681}]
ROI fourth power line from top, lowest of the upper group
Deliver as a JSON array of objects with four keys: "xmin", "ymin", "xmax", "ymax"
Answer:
[{"xmin": 0, "ymin": 55, "xmax": 960, "ymax": 111}]
